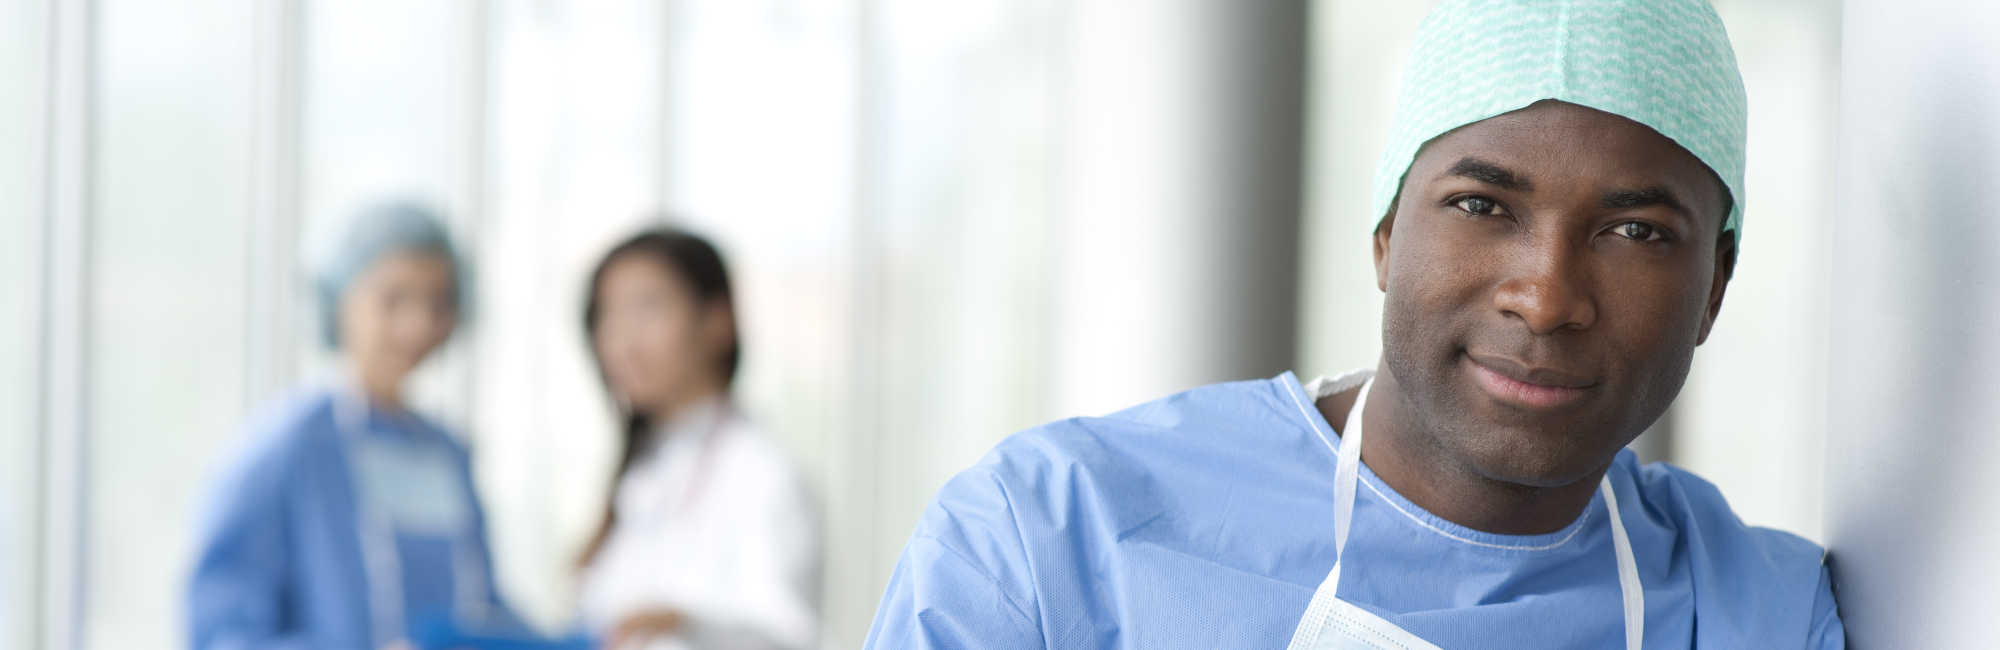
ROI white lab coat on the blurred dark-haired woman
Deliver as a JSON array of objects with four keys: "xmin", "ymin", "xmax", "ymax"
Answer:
[{"xmin": 578, "ymin": 400, "xmax": 822, "ymax": 650}]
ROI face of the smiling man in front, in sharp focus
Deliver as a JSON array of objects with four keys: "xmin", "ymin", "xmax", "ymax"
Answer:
[{"xmin": 1376, "ymin": 102, "xmax": 1734, "ymax": 486}]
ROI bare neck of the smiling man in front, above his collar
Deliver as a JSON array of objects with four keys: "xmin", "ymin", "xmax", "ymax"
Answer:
[{"xmin": 1318, "ymin": 366, "xmax": 1602, "ymax": 534}]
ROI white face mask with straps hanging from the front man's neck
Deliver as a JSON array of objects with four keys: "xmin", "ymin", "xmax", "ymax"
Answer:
[{"xmin": 1286, "ymin": 378, "xmax": 1646, "ymax": 650}]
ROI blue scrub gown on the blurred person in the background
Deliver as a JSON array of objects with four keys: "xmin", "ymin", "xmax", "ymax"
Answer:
[{"xmin": 188, "ymin": 390, "xmax": 522, "ymax": 650}]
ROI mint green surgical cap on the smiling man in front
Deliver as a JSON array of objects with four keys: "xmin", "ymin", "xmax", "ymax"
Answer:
[{"xmin": 1374, "ymin": 0, "xmax": 1750, "ymax": 238}]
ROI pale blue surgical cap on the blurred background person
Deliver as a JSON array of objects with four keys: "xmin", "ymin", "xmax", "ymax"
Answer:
[{"xmin": 312, "ymin": 200, "xmax": 470, "ymax": 348}]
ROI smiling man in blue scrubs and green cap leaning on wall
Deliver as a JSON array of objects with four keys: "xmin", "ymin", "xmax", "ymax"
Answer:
[{"xmin": 868, "ymin": 0, "xmax": 1844, "ymax": 648}]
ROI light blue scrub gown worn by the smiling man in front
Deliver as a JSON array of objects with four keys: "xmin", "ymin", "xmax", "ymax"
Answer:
[{"xmin": 868, "ymin": 372, "xmax": 1844, "ymax": 648}]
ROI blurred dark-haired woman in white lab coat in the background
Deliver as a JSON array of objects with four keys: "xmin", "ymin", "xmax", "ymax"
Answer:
[{"xmin": 580, "ymin": 228, "xmax": 822, "ymax": 648}]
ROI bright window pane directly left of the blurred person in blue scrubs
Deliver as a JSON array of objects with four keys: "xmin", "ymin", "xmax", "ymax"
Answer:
[{"xmin": 82, "ymin": 0, "xmax": 254, "ymax": 648}]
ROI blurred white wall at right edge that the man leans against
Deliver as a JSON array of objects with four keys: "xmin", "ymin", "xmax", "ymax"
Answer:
[{"xmin": 1826, "ymin": 0, "xmax": 2000, "ymax": 650}]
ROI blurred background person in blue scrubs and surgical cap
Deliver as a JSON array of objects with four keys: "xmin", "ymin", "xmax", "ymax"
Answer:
[{"xmin": 188, "ymin": 204, "xmax": 520, "ymax": 650}]
